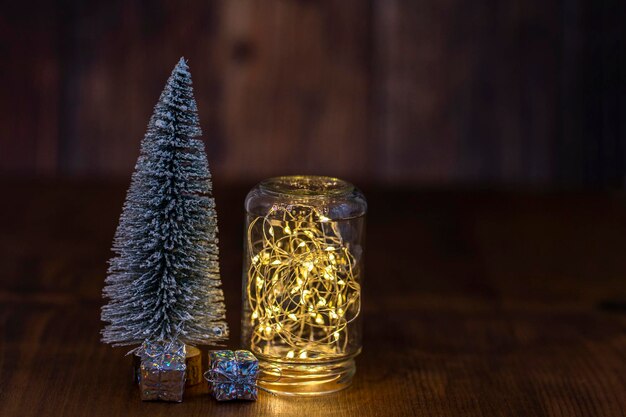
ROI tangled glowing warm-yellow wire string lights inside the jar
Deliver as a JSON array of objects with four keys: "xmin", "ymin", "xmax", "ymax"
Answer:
[{"xmin": 246, "ymin": 205, "xmax": 361, "ymax": 360}]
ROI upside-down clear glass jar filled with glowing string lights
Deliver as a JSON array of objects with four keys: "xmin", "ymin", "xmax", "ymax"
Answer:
[{"xmin": 242, "ymin": 176, "xmax": 367, "ymax": 395}]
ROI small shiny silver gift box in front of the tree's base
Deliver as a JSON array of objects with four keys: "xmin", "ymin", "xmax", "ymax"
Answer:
[{"xmin": 139, "ymin": 341, "xmax": 186, "ymax": 402}]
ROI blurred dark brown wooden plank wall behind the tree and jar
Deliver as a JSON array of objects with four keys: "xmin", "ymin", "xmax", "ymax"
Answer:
[{"xmin": 0, "ymin": 0, "xmax": 626, "ymax": 185}]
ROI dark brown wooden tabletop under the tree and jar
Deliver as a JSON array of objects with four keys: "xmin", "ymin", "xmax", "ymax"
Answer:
[{"xmin": 0, "ymin": 180, "xmax": 626, "ymax": 417}]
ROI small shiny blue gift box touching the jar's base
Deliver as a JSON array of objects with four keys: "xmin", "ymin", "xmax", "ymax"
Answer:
[{"xmin": 206, "ymin": 350, "xmax": 259, "ymax": 401}]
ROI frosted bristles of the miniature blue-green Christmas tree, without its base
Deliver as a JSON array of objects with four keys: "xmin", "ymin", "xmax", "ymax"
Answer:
[{"xmin": 102, "ymin": 58, "xmax": 228, "ymax": 346}]
